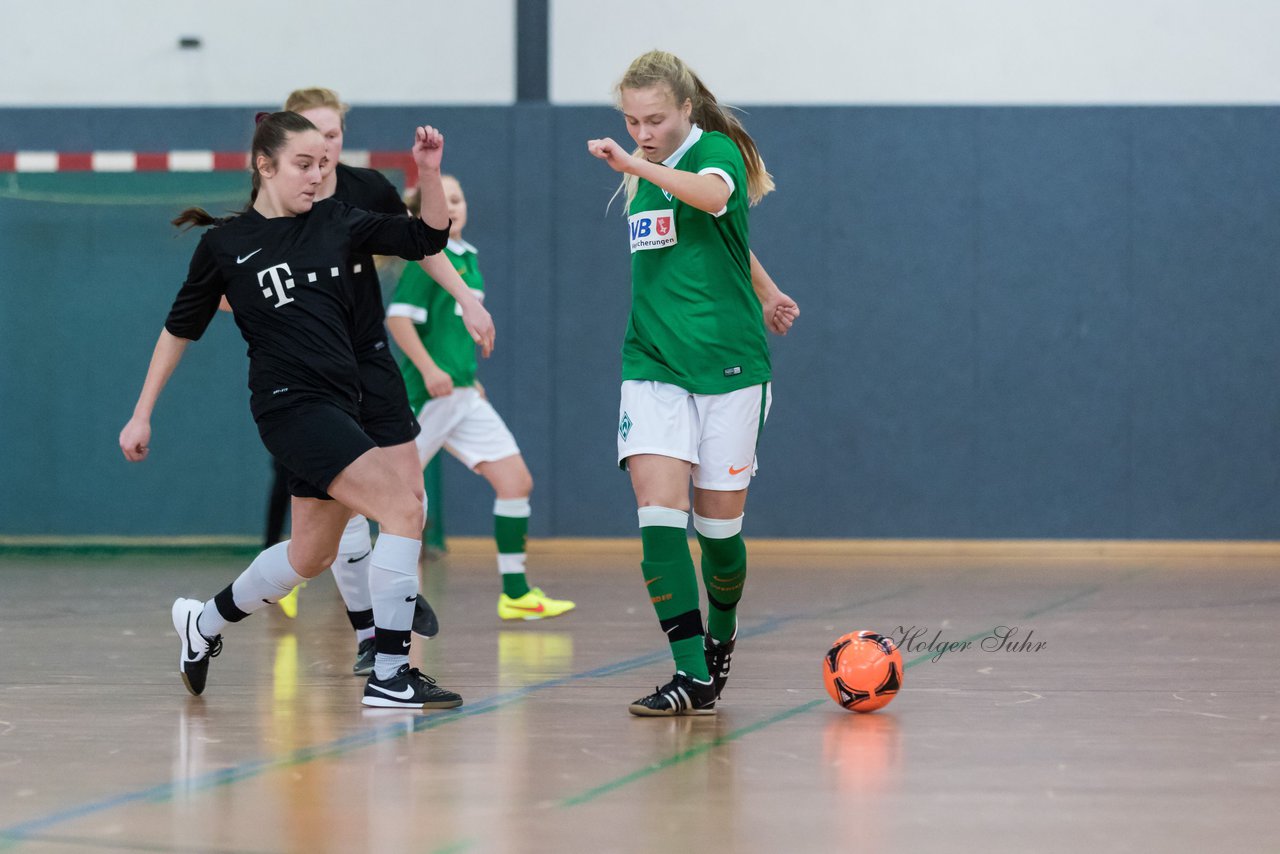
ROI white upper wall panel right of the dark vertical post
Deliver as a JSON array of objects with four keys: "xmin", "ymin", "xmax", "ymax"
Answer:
[{"xmin": 550, "ymin": 0, "xmax": 1280, "ymax": 104}]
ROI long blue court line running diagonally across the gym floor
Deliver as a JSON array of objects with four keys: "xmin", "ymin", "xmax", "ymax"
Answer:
[{"xmin": 0, "ymin": 584, "xmax": 920, "ymax": 851}]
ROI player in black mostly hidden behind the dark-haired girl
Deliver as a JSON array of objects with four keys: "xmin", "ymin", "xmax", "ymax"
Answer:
[{"xmin": 277, "ymin": 87, "xmax": 494, "ymax": 675}]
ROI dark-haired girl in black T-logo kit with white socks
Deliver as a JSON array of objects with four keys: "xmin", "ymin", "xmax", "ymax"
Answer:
[{"xmin": 120, "ymin": 113, "xmax": 462, "ymax": 708}]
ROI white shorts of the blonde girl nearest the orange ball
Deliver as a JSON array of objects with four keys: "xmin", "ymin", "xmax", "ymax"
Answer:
[{"xmin": 618, "ymin": 379, "xmax": 773, "ymax": 492}]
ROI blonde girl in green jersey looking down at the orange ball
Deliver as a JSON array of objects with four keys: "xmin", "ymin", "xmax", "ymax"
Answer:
[{"xmin": 588, "ymin": 51, "xmax": 800, "ymax": 716}]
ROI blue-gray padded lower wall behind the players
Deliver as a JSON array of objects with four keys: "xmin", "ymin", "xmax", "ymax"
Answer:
[{"xmin": 0, "ymin": 106, "xmax": 1280, "ymax": 539}]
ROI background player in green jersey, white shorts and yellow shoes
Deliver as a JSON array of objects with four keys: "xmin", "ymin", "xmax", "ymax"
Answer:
[{"xmin": 387, "ymin": 175, "xmax": 573, "ymax": 620}]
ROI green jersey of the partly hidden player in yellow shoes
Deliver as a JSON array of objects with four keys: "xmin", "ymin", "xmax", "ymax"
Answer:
[{"xmin": 387, "ymin": 238, "xmax": 484, "ymax": 412}]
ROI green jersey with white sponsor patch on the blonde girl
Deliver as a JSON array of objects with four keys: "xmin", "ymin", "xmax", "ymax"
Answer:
[{"xmin": 622, "ymin": 124, "xmax": 769, "ymax": 394}]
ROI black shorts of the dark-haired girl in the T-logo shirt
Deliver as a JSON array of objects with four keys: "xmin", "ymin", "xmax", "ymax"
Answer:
[{"xmin": 257, "ymin": 397, "xmax": 378, "ymax": 501}]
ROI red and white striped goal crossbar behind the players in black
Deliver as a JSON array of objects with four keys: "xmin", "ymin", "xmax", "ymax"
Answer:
[{"xmin": 0, "ymin": 150, "xmax": 417, "ymax": 186}]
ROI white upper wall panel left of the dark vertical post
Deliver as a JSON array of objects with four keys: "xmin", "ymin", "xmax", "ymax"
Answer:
[{"xmin": 0, "ymin": 0, "xmax": 516, "ymax": 106}]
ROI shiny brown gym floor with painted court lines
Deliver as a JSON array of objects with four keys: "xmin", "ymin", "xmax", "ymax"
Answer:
[{"xmin": 0, "ymin": 540, "xmax": 1280, "ymax": 854}]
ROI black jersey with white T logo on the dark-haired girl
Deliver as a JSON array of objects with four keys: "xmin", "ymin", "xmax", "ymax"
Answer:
[{"xmin": 165, "ymin": 198, "xmax": 448, "ymax": 419}]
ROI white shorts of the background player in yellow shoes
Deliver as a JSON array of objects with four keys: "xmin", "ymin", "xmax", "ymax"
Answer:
[{"xmin": 413, "ymin": 388, "xmax": 520, "ymax": 469}]
